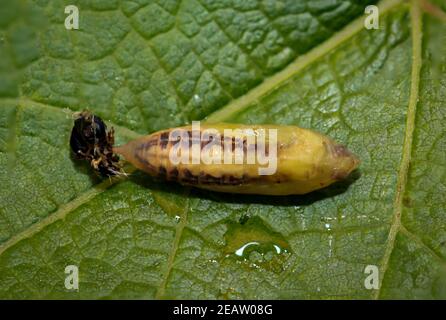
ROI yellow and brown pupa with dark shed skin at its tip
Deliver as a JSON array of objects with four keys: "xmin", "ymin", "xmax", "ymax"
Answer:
[{"xmin": 71, "ymin": 112, "xmax": 359, "ymax": 195}]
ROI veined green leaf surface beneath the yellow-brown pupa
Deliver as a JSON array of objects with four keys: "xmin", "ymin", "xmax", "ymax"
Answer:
[{"xmin": 0, "ymin": 0, "xmax": 446, "ymax": 299}]
